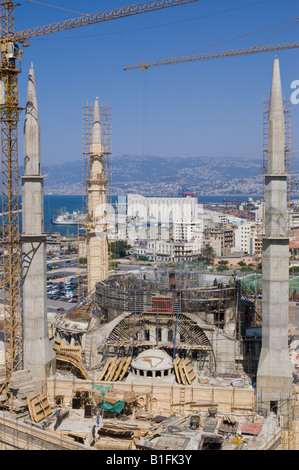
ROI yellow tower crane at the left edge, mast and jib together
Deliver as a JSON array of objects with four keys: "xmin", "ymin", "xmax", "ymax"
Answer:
[{"xmin": 0, "ymin": 0, "xmax": 203, "ymax": 395}]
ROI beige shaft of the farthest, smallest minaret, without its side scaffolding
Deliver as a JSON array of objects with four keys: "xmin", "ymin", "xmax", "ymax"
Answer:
[{"xmin": 86, "ymin": 98, "xmax": 108, "ymax": 292}]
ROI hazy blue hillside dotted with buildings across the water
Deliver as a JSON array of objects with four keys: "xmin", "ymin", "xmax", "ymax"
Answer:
[{"xmin": 44, "ymin": 155, "xmax": 299, "ymax": 196}]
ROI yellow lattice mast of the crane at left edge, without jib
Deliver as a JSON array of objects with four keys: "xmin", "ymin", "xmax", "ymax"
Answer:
[{"xmin": 0, "ymin": 1, "xmax": 22, "ymax": 396}]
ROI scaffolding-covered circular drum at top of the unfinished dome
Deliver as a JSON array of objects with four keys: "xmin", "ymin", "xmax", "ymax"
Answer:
[{"xmin": 96, "ymin": 271, "xmax": 237, "ymax": 315}]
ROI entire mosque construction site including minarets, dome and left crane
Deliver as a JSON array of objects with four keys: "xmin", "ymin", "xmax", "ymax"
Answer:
[{"xmin": 0, "ymin": 0, "xmax": 299, "ymax": 453}]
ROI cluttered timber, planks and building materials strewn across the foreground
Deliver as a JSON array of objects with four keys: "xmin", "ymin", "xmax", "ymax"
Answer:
[{"xmin": 0, "ymin": 371, "xmax": 294, "ymax": 452}]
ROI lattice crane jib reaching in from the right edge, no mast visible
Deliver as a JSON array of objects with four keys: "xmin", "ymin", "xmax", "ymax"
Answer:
[{"xmin": 124, "ymin": 42, "xmax": 299, "ymax": 70}]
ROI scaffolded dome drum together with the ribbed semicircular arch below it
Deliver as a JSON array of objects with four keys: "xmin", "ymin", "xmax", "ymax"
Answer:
[{"xmin": 95, "ymin": 269, "xmax": 238, "ymax": 374}]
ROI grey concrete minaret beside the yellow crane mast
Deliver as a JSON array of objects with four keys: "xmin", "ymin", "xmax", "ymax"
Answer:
[{"xmin": 21, "ymin": 65, "xmax": 55, "ymax": 390}]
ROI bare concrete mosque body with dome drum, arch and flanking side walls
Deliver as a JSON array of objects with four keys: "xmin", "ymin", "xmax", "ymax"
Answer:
[{"xmin": 77, "ymin": 268, "xmax": 240, "ymax": 376}]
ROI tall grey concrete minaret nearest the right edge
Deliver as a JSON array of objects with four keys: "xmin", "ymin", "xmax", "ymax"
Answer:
[{"xmin": 257, "ymin": 58, "xmax": 293, "ymax": 409}]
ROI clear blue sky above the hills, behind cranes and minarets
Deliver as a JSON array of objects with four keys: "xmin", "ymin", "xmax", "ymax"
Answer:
[{"xmin": 15, "ymin": 0, "xmax": 299, "ymax": 166}]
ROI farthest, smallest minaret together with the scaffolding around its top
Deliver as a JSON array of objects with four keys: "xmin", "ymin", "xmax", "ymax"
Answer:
[{"xmin": 85, "ymin": 98, "xmax": 111, "ymax": 292}]
